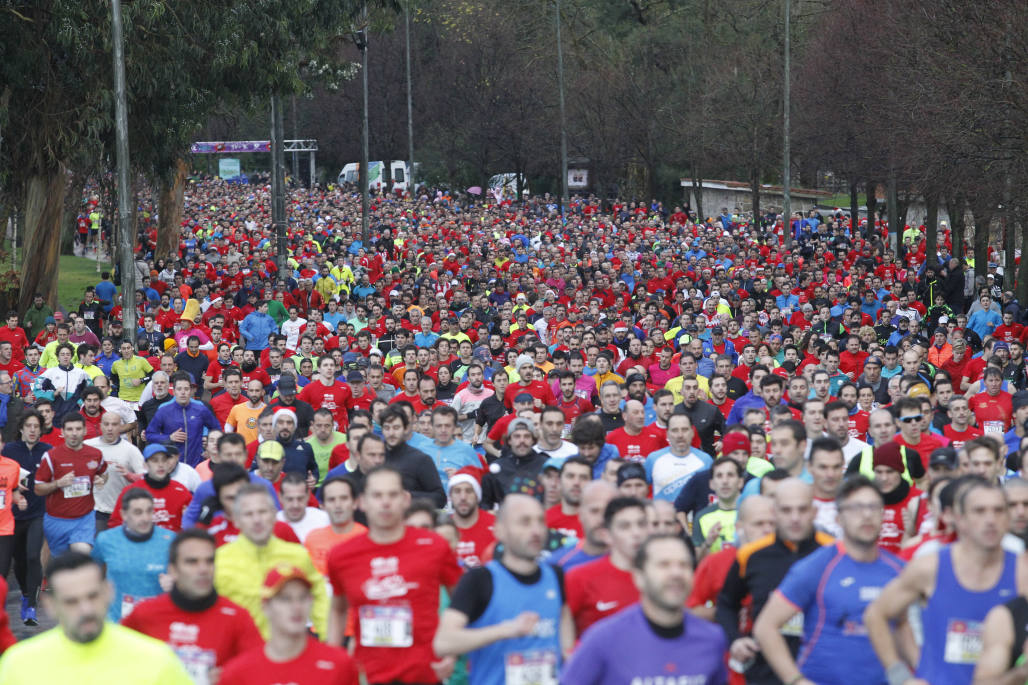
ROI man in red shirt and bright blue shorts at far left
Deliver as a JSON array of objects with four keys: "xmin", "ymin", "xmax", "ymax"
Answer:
[{"xmin": 35, "ymin": 413, "xmax": 107, "ymax": 555}]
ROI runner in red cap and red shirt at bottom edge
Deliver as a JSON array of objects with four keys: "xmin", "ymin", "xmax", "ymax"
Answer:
[{"xmin": 218, "ymin": 564, "xmax": 360, "ymax": 685}]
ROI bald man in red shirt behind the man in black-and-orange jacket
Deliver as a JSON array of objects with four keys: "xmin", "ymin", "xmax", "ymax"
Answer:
[{"xmin": 690, "ymin": 495, "xmax": 774, "ymax": 621}]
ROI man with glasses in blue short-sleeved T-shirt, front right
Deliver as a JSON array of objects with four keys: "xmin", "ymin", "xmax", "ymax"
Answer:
[{"xmin": 754, "ymin": 476, "xmax": 903, "ymax": 685}]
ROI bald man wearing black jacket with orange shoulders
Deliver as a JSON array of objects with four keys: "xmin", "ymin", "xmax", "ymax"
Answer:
[{"xmin": 714, "ymin": 477, "xmax": 833, "ymax": 685}]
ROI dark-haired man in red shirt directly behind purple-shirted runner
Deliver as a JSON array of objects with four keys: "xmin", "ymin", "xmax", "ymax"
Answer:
[{"xmin": 564, "ymin": 497, "xmax": 649, "ymax": 636}]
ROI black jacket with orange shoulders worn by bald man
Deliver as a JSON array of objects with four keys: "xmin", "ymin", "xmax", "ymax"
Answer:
[{"xmin": 715, "ymin": 532, "xmax": 835, "ymax": 685}]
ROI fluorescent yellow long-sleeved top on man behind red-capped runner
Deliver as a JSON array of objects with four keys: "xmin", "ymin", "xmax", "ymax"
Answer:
[{"xmin": 214, "ymin": 535, "xmax": 328, "ymax": 640}]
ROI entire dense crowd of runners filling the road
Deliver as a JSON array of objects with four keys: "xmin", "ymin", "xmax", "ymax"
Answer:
[{"xmin": 0, "ymin": 180, "xmax": 1028, "ymax": 685}]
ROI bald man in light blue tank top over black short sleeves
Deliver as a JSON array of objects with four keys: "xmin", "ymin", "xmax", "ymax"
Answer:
[{"xmin": 433, "ymin": 494, "xmax": 574, "ymax": 685}]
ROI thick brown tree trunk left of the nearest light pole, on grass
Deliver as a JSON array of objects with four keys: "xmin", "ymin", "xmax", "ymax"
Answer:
[{"xmin": 17, "ymin": 166, "xmax": 68, "ymax": 314}]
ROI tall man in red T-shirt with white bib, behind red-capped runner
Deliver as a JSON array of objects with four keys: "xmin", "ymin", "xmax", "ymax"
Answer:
[{"xmin": 326, "ymin": 466, "xmax": 461, "ymax": 683}]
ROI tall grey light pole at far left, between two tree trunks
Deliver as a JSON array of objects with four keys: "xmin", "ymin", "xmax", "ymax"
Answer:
[{"xmin": 111, "ymin": 0, "xmax": 136, "ymax": 345}]
